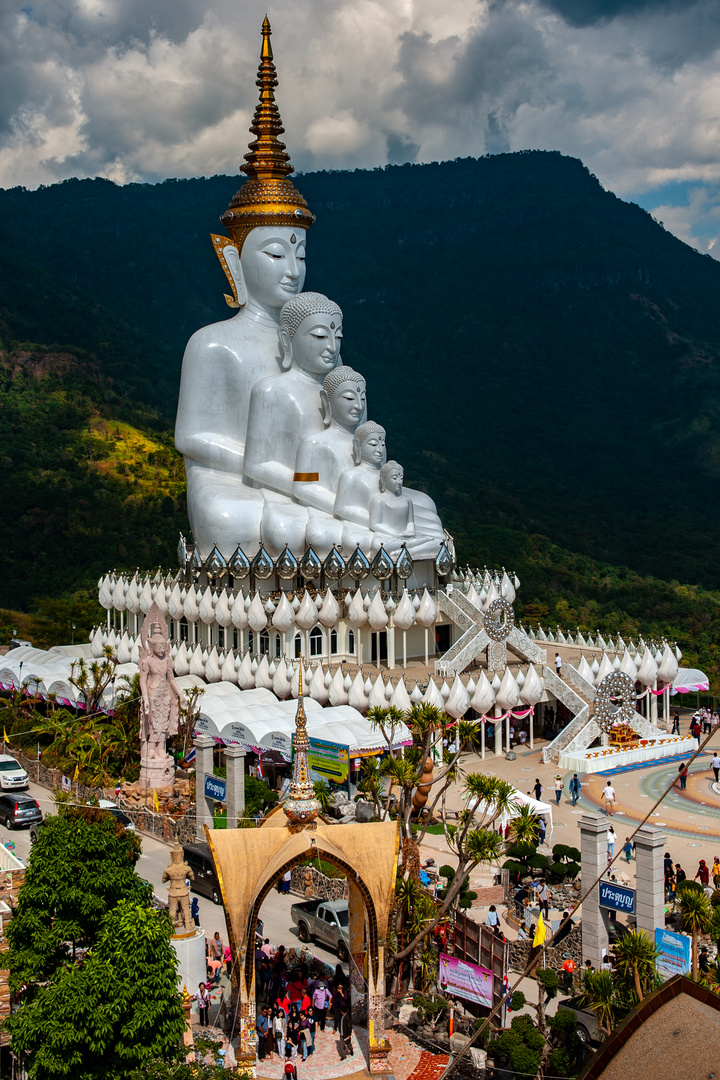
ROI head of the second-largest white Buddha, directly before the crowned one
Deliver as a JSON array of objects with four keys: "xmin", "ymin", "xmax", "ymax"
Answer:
[{"xmin": 277, "ymin": 293, "xmax": 342, "ymax": 382}]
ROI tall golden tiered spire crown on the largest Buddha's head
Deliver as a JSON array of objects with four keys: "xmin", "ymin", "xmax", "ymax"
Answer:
[{"xmin": 214, "ymin": 15, "xmax": 315, "ymax": 252}]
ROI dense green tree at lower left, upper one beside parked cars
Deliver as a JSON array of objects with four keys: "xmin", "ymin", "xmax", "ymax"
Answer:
[{"xmin": 8, "ymin": 807, "xmax": 146, "ymax": 997}]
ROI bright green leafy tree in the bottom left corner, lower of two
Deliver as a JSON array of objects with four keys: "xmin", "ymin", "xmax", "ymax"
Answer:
[{"xmin": 8, "ymin": 899, "xmax": 185, "ymax": 1080}]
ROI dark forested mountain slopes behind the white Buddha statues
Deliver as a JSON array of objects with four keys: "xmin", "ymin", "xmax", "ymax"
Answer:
[{"xmin": 0, "ymin": 152, "xmax": 720, "ymax": 673}]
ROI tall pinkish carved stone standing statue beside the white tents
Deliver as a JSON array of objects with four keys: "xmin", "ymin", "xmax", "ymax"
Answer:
[{"xmin": 139, "ymin": 603, "xmax": 180, "ymax": 791}]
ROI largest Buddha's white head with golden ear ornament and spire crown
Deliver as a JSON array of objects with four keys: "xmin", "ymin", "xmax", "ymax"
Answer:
[{"xmin": 213, "ymin": 16, "xmax": 315, "ymax": 320}]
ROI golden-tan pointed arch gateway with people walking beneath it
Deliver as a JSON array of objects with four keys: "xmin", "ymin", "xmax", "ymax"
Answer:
[{"xmin": 205, "ymin": 816, "xmax": 399, "ymax": 1076}]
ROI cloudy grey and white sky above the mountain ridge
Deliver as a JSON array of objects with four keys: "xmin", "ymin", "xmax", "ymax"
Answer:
[{"xmin": 0, "ymin": 0, "xmax": 720, "ymax": 257}]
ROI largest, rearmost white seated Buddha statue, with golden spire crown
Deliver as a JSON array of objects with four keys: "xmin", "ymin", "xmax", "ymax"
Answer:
[{"xmin": 175, "ymin": 18, "xmax": 314, "ymax": 557}]
